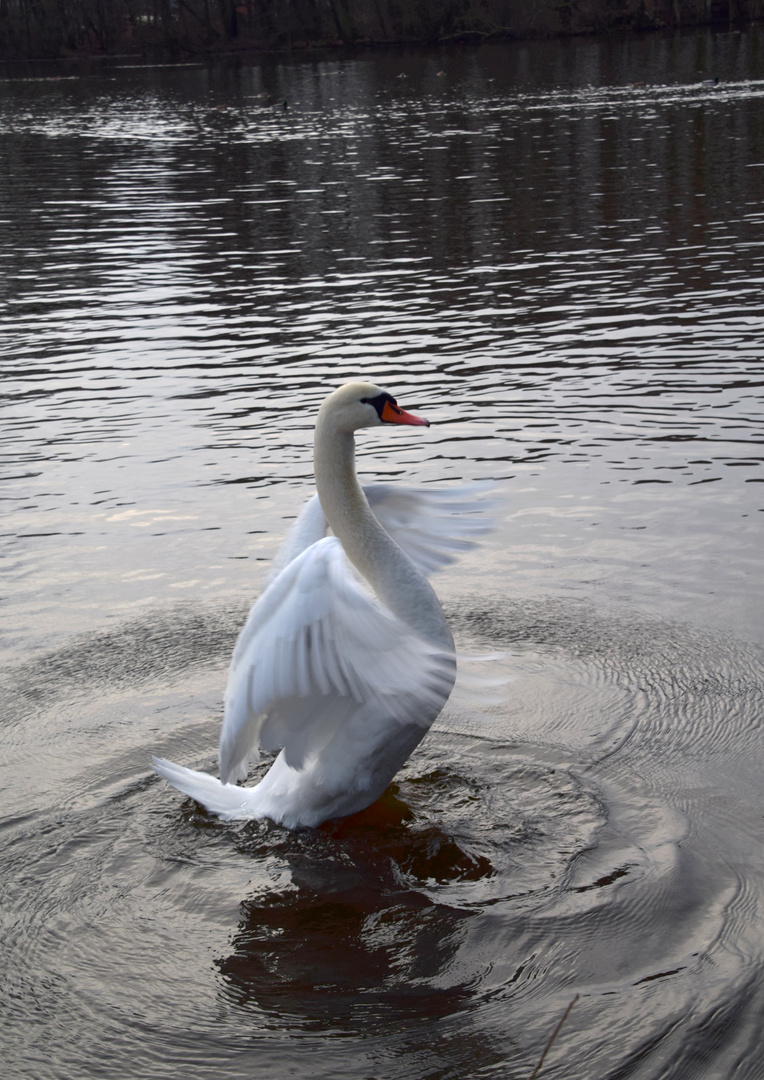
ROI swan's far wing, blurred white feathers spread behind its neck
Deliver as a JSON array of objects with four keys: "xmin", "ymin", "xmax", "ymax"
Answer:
[{"xmin": 363, "ymin": 483, "xmax": 492, "ymax": 575}]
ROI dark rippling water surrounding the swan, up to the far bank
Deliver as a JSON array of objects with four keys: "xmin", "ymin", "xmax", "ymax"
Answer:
[{"xmin": 0, "ymin": 27, "xmax": 764, "ymax": 1080}]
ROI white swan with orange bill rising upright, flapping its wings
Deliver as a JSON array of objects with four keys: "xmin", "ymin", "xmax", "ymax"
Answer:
[{"xmin": 153, "ymin": 382, "xmax": 485, "ymax": 828}]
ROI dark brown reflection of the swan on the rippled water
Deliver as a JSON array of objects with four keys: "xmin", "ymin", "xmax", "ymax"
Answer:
[{"xmin": 219, "ymin": 832, "xmax": 470, "ymax": 1034}]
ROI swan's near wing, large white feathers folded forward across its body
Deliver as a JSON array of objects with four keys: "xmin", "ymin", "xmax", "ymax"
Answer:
[{"xmin": 220, "ymin": 537, "xmax": 455, "ymax": 782}]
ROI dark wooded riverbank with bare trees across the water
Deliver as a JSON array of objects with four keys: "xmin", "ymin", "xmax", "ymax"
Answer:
[{"xmin": 0, "ymin": 0, "xmax": 764, "ymax": 60}]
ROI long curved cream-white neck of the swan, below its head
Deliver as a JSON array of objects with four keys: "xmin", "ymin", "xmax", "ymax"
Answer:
[{"xmin": 314, "ymin": 414, "xmax": 453, "ymax": 649}]
